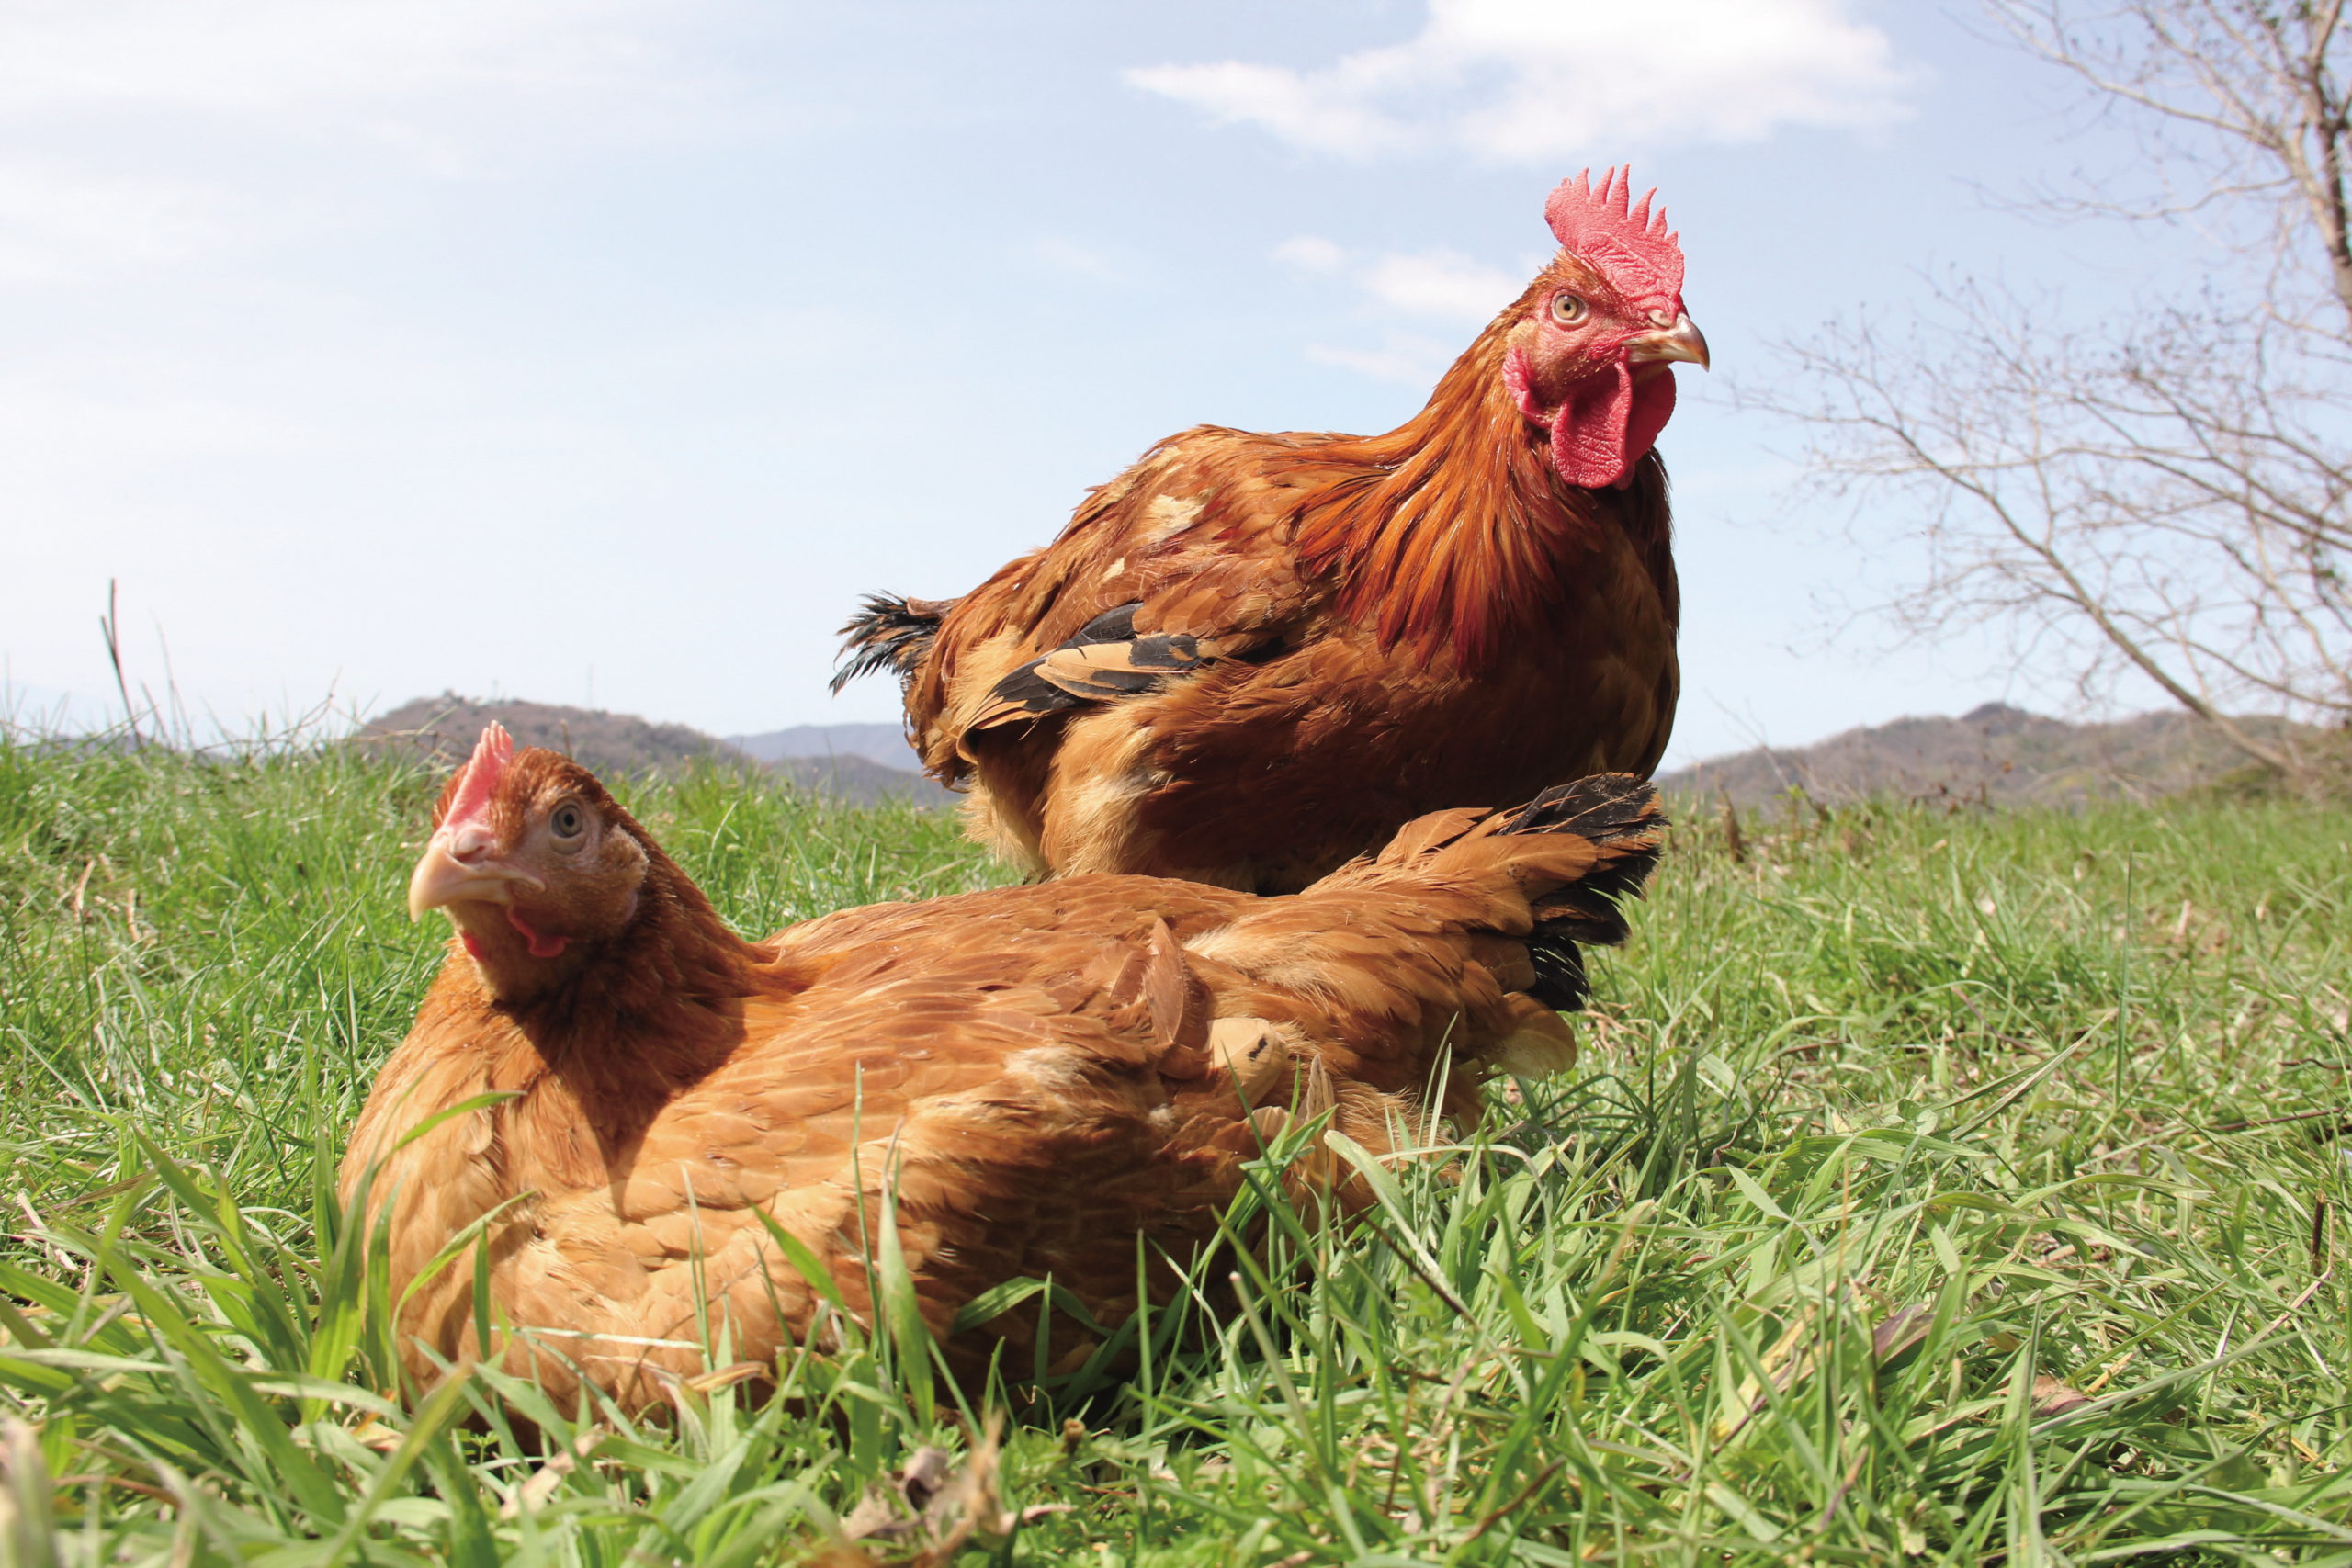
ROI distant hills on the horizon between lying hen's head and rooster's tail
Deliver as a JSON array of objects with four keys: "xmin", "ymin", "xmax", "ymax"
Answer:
[{"xmin": 357, "ymin": 691, "xmax": 955, "ymax": 807}]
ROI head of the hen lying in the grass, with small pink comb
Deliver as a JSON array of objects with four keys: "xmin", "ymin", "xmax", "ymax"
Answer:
[{"xmin": 409, "ymin": 724, "xmax": 654, "ymax": 1001}]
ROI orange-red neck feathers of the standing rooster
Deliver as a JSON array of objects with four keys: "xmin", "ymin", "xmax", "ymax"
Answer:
[{"xmin": 1298, "ymin": 280, "xmax": 1627, "ymax": 668}]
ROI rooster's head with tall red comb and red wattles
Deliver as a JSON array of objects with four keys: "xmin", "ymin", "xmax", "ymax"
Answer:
[{"xmin": 1503, "ymin": 169, "xmax": 1708, "ymax": 489}]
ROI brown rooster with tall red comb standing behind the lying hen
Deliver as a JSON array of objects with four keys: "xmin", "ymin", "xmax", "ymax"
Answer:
[{"xmin": 832, "ymin": 172, "xmax": 1708, "ymax": 894}]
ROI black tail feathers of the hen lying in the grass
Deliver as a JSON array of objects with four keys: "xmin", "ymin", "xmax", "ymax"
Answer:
[{"xmin": 1500, "ymin": 773, "xmax": 1668, "ymax": 1013}]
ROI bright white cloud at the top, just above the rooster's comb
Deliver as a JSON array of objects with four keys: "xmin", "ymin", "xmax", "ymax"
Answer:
[{"xmin": 1126, "ymin": 0, "xmax": 1907, "ymax": 163}]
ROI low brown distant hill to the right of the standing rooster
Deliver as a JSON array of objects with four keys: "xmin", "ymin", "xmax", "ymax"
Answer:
[{"xmin": 1658, "ymin": 703, "xmax": 2307, "ymax": 807}]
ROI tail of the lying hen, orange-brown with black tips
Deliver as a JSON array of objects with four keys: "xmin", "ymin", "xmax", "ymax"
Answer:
[{"xmin": 1376, "ymin": 773, "xmax": 1668, "ymax": 1013}]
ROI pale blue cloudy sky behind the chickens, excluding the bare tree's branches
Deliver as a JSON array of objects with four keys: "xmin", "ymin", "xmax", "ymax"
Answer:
[{"xmin": 0, "ymin": 0, "xmax": 2188, "ymax": 761}]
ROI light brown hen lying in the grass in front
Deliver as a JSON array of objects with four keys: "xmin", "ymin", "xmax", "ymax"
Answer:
[{"xmin": 341, "ymin": 727, "xmax": 1663, "ymax": 1408}]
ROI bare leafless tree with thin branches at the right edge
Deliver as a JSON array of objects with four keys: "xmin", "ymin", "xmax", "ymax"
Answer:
[{"xmin": 1750, "ymin": 0, "xmax": 2352, "ymax": 783}]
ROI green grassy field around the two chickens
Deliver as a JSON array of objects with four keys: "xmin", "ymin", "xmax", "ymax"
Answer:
[{"xmin": 0, "ymin": 743, "xmax": 2352, "ymax": 1568}]
